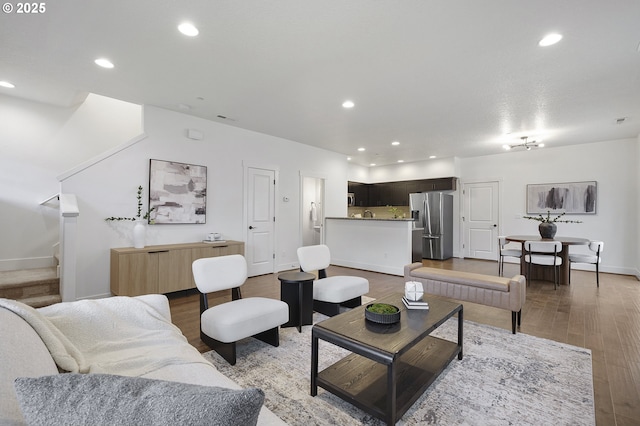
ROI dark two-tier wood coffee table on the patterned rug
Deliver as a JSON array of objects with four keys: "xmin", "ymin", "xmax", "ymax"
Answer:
[{"xmin": 311, "ymin": 293, "xmax": 464, "ymax": 425}]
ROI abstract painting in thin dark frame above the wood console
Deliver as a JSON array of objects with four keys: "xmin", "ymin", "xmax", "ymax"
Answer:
[{"xmin": 149, "ymin": 159, "xmax": 207, "ymax": 225}]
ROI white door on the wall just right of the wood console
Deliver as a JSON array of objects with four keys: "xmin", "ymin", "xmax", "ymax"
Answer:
[{"xmin": 245, "ymin": 167, "xmax": 275, "ymax": 276}]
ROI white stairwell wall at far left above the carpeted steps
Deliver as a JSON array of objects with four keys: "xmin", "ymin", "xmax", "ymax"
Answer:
[{"xmin": 0, "ymin": 95, "xmax": 141, "ymax": 270}]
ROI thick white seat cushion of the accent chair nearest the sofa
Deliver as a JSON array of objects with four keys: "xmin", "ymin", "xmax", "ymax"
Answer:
[{"xmin": 201, "ymin": 297, "xmax": 289, "ymax": 343}]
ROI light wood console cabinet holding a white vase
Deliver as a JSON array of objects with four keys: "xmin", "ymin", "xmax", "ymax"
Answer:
[{"xmin": 111, "ymin": 241, "xmax": 244, "ymax": 296}]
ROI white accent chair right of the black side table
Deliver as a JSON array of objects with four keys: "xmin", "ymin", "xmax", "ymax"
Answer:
[{"xmin": 297, "ymin": 244, "xmax": 369, "ymax": 317}]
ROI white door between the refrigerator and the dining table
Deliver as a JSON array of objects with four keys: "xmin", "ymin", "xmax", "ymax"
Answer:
[{"xmin": 463, "ymin": 182, "xmax": 499, "ymax": 260}]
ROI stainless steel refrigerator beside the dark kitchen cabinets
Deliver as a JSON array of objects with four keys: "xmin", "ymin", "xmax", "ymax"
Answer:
[{"xmin": 409, "ymin": 192, "xmax": 453, "ymax": 260}]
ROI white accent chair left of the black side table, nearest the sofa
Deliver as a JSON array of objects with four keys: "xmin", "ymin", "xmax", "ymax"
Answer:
[{"xmin": 191, "ymin": 254, "xmax": 289, "ymax": 365}]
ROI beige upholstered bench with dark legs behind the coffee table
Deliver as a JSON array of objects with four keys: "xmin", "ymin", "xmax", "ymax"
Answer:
[{"xmin": 404, "ymin": 262, "xmax": 527, "ymax": 334}]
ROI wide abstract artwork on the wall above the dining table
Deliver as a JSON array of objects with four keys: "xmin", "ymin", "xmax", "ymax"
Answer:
[{"xmin": 527, "ymin": 181, "xmax": 598, "ymax": 214}]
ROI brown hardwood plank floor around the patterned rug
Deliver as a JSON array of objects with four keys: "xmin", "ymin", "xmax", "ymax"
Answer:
[{"xmin": 170, "ymin": 259, "xmax": 640, "ymax": 426}]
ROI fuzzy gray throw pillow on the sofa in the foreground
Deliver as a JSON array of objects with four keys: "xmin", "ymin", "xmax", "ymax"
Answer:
[{"xmin": 14, "ymin": 373, "xmax": 264, "ymax": 426}]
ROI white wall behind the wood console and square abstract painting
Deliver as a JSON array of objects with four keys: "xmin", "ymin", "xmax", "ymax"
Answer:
[{"xmin": 62, "ymin": 106, "xmax": 347, "ymax": 298}]
